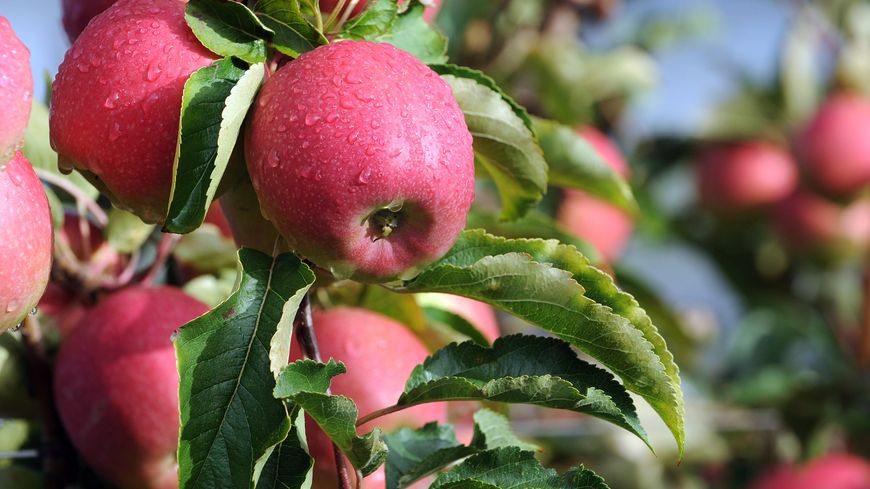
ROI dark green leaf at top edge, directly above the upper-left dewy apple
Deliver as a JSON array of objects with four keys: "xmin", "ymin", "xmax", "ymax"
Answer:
[{"xmin": 184, "ymin": 0, "xmax": 275, "ymax": 64}]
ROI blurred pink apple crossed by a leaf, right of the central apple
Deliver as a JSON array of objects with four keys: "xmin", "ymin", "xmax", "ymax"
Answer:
[{"xmin": 557, "ymin": 127, "xmax": 634, "ymax": 262}]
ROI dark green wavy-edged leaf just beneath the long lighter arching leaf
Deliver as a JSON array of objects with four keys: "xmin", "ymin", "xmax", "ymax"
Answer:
[{"xmin": 396, "ymin": 335, "xmax": 649, "ymax": 443}]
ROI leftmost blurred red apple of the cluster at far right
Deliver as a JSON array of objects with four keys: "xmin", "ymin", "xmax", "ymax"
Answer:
[{"xmin": 697, "ymin": 141, "xmax": 799, "ymax": 213}]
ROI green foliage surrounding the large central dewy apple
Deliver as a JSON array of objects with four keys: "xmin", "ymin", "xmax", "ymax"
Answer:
[{"xmin": 158, "ymin": 0, "xmax": 684, "ymax": 489}]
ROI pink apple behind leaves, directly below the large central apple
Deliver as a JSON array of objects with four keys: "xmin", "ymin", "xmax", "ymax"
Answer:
[{"xmin": 291, "ymin": 307, "xmax": 447, "ymax": 489}]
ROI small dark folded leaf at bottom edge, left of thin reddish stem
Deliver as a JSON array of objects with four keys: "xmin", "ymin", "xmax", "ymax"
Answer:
[{"xmin": 256, "ymin": 409, "xmax": 314, "ymax": 489}]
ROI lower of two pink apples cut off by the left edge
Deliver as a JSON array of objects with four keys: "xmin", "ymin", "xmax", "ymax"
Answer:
[{"xmin": 0, "ymin": 151, "xmax": 52, "ymax": 334}]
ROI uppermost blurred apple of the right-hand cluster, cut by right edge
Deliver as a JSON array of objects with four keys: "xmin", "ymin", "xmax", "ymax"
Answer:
[{"xmin": 796, "ymin": 93, "xmax": 870, "ymax": 195}]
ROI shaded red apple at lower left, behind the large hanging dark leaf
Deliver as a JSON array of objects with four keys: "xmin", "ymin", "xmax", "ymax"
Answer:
[{"xmin": 54, "ymin": 287, "xmax": 208, "ymax": 489}]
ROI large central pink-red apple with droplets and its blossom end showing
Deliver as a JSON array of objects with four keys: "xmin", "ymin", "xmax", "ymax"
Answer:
[{"xmin": 246, "ymin": 41, "xmax": 474, "ymax": 282}]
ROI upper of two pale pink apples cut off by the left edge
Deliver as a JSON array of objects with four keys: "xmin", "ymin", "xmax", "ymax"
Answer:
[{"xmin": 0, "ymin": 16, "xmax": 33, "ymax": 165}]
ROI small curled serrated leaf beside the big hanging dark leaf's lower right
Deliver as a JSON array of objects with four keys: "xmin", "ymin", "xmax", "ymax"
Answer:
[{"xmin": 274, "ymin": 359, "xmax": 387, "ymax": 475}]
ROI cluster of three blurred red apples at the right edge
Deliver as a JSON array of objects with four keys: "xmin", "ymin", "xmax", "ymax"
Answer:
[{"xmin": 697, "ymin": 92, "xmax": 870, "ymax": 260}]
